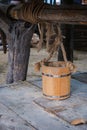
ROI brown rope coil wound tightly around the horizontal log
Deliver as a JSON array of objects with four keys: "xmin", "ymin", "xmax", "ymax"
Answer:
[{"xmin": 10, "ymin": 0, "xmax": 45, "ymax": 24}]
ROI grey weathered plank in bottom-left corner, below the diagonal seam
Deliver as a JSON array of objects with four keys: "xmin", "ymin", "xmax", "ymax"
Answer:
[{"xmin": 0, "ymin": 102, "xmax": 36, "ymax": 130}]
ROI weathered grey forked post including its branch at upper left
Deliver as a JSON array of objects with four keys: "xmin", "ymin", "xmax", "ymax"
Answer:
[{"xmin": 0, "ymin": 4, "xmax": 34, "ymax": 83}]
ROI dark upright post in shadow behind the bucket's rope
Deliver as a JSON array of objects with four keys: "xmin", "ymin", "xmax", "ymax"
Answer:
[{"xmin": 58, "ymin": 24, "xmax": 74, "ymax": 62}]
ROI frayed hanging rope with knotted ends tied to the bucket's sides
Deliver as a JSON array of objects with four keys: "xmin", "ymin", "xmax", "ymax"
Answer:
[{"xmin": 35, "ymin": 24, "xmax": 76, "ymax": 73}]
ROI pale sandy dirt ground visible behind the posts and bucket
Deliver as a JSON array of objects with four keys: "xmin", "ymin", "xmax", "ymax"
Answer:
[{"xmin": 0, "ymin": 48, "xmax": 87, "ymax": 84}]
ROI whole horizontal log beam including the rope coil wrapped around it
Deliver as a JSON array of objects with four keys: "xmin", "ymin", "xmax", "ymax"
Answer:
[{"xmin": 9, "ymin": 1, "xmax": 87, "ymax": 24}]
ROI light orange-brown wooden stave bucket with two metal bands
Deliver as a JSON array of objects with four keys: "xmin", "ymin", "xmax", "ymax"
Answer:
[{"xmin": 42, "ymin": 61, "xmax": 71, "ymax": 100}]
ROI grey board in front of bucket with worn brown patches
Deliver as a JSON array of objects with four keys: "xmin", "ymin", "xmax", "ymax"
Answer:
[{"xmin": 34, "ymin": 95, "xmax": 87, "ymax": 123}]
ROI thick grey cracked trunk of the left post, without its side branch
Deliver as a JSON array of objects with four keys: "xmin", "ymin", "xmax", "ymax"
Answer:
[{"xmin": 6, "ymin": 21, "xmax": 34, "ymax": 83}]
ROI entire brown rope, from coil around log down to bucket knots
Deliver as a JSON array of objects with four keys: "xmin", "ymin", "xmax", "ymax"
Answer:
[{"xmin": 10, "ymin": 0, "xmax": 75, "ymax": 71}]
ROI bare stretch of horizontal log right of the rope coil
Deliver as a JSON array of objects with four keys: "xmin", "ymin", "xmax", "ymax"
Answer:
[{"xmin": 39, "ymin": 5, "xmax": 87, "ymax": 24}]
